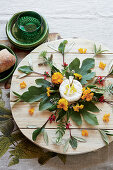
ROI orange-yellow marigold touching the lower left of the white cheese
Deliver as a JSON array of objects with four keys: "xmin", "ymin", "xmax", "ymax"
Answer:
[{"xmin": 57, "ymin": 98, "xmax": 68, "ymax": 111}]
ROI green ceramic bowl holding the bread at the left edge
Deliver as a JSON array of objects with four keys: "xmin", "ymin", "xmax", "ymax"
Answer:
[{"xmin": 0, "ymin": 44, "xmax": 17, "ymax": 83}]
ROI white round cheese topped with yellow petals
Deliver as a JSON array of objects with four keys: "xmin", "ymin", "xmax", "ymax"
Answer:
[{"xmin": 59, "ymin": 76, "xmax": 82, "ymax": 102}]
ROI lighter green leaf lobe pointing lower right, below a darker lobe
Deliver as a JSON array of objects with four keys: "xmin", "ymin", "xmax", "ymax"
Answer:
[{"xmin": 80, "ymin": 110, "xmax": 98, "ymax": 125}]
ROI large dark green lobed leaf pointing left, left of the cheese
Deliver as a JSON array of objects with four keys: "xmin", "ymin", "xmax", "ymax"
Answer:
[{"xmin": 21, "ymin": 86, "xmax": 47, "ymax": 103}]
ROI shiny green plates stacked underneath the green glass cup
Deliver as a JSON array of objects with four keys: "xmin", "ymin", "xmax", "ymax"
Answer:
[{"xmin": 6, "ymin": 11, "xmax": 49, "ymax": 50}]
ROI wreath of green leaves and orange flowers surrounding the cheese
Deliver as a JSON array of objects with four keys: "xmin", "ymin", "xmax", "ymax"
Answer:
[{"xmin": 13, "ymin": 40, "xmax": 113, "ymax": 152}]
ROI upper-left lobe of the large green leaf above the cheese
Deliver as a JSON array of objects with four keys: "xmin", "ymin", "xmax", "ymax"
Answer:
[{"xmin": 69, "ymin": 58, "xmax": 80, "ymax": 73}]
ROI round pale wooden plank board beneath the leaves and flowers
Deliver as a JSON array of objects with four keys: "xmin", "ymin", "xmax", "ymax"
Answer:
[{"xmin": 10, "ymin": 39, "xmax": 113, "ymax": 155}]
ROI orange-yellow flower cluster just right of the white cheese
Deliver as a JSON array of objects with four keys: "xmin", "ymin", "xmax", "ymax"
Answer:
[{"xmin": 81, "ymin": 87, "xmax": 94, "ymax": 102}]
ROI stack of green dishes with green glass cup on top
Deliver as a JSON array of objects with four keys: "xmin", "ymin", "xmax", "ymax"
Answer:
[{"xmin": 6, "ymin": 11, "xmax": 49, "ymax": 50}]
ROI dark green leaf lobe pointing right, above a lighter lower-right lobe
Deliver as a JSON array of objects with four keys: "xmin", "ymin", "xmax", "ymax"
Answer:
[{"xmin": 82, "ymin": 102, "xmax": 100, "ymax": 112}]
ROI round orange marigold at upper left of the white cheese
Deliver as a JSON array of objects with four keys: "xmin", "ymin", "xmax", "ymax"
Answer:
[{"xmin": 52, "ymin": 72, "xmax": 63, "ymax": 84}]
